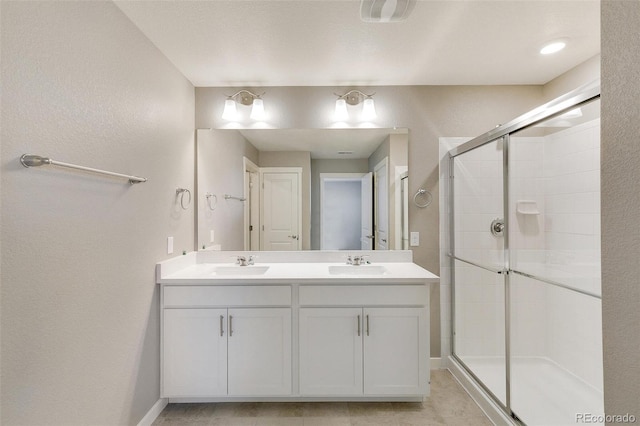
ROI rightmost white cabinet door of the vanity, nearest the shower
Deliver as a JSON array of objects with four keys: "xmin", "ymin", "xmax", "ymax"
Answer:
[{"xmin": 364, "ymin": 308, "xmax": 429, "ymax": 395}]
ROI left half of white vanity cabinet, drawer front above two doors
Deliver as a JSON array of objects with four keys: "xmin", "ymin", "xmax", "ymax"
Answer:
[{"xmin": 162, "ymin": 286, "xmax": 291, "ymax": 398}]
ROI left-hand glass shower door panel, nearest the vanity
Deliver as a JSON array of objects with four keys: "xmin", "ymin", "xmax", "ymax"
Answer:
[{"xmin": 451, "ymin": 138, "xmax": 508, "ymax": 407}]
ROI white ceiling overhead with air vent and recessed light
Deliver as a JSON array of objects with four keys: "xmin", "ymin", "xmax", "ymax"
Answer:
[{"xmin": 116, "ymin": 0, "xmax": 600, "ymax": 87}]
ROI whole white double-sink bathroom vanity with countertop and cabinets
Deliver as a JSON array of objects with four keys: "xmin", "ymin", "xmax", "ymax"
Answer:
[{"xmin": 156, "ymin": 251, "xmax": 438, "ymax": 402}]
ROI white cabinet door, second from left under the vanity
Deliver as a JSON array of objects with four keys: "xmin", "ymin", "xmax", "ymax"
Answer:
[{"xmin": 228, "ymin": 308, "xmax": 291, "ymax": 396}]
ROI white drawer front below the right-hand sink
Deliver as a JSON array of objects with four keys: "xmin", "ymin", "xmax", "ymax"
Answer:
[{"xmin": 300, "ymin": 285, "xmax": 429, "ymax": 306}]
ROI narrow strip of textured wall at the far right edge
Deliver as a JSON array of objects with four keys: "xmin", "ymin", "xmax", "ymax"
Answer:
[{"xmin": 601, "ymin": 0, "xmax": 640, "ymax": 419}]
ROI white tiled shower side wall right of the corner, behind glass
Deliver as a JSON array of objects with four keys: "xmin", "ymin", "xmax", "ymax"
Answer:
[{"xmin": 544, "ymin": 120, "xmax": 602, "ymax": 390}]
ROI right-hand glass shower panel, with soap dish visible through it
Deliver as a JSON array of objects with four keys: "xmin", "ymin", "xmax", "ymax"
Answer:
[{"xmin": 509, "ymin": 100, "xmax": 604, "ymax": 426}]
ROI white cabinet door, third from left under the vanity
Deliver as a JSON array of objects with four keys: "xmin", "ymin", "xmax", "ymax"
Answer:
[{"xmin": 299, "ymin": 308, "xmax": 362, "ymax": 396}]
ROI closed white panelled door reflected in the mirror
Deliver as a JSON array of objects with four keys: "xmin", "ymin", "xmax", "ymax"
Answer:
[{"xmin": 260, "ymin": 169, "xmax": 302, "ymax": 251}]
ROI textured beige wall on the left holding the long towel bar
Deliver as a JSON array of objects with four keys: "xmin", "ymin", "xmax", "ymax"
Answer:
[{"xmin": 0, "ymin": 1, "xmax": 194, "ymax": 425}]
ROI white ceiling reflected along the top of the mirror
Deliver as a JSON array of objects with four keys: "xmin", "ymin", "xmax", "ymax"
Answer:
[{"xmin": 235, "ymin": 128, "xmax": 408, "ymax": 159}]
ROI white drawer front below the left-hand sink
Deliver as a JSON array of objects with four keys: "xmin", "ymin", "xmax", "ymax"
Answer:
[{"xmin": 164, "ymin": 285, "xmax": 291, "ymax": 307}]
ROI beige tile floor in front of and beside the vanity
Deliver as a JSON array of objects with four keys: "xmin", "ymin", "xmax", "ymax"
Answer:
[{"xmin": 153, "ymin": 370, "xmax": 492, "ymax": 426}]
